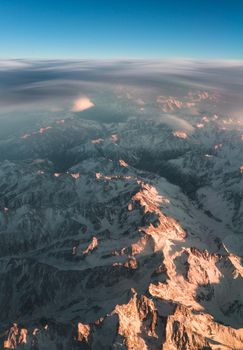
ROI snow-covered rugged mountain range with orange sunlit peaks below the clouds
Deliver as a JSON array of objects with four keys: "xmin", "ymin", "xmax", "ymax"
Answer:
[{"xmin": 0, "ymin": 91, "xmax": 243, "ymax": 350}]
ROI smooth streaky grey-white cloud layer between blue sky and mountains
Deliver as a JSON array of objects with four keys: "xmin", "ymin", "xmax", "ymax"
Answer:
[{"xmin": 0, "ymin": 59, "xmax": 243, "ymax": 114}]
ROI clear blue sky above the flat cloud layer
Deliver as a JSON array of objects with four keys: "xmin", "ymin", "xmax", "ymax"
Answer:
[{"xmin": 0, "ymin": 0, "xmax": 243, "ymax": 59}]
